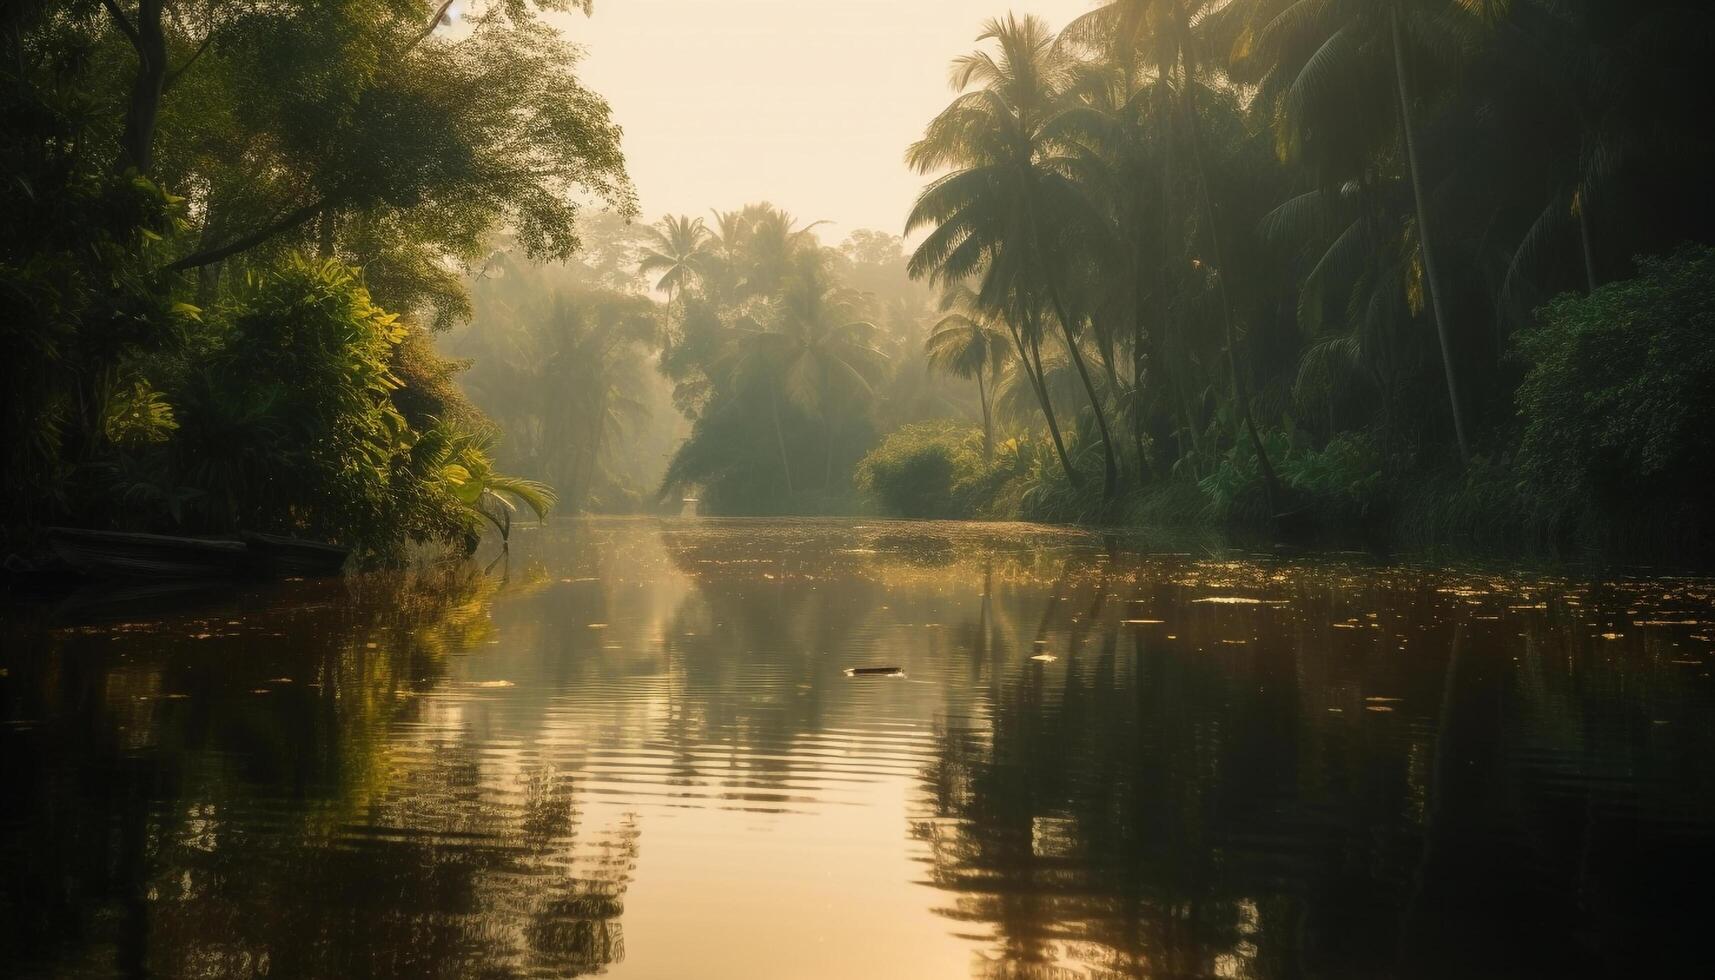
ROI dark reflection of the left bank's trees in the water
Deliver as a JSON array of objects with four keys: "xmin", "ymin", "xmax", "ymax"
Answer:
[{"xmin": 0, "ymin": 572, "xmax": 636, "ymax": 977}]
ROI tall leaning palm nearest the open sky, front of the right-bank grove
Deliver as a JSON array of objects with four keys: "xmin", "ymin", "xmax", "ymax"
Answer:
[{"xmin": 906, "ymin": 15, "xmax": 1118, "ymax": 499}]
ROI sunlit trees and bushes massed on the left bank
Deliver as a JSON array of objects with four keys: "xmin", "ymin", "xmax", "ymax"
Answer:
[{"xmin": 0, "ymin": 0, "xmax": 633, "ymax": 554}]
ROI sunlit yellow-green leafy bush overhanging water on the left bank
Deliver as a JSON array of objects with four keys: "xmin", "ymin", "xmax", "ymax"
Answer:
[{"xmin": 161, "ymin": 256, "xmax": 554, "ymax": 560}]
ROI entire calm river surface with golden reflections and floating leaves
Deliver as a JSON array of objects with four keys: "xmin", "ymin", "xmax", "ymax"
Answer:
[{"xmin": 0, "ymin": 520, "xmax": 1715, "ymax": 980}]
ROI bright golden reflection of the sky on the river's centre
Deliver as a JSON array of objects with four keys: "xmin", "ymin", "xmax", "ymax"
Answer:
[{"xmin": 453, "ymin": 529, "xmax": 979, "ymax": 980}]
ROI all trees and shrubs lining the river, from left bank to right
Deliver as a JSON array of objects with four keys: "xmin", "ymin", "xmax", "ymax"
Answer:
[{"xmin": 0, "ymin": 0, "xmax": 1715, "ymax": 565}]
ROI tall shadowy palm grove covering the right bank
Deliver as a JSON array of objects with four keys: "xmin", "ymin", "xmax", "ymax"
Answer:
[{"xmin": 884, "ymin": 0, "xmax": 1715, "ymax": 552}]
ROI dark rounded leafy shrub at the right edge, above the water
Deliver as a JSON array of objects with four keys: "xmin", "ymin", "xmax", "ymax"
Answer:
[{"xmin": 1518, "ymin": 245, "xmax": 1715, "ymax": 545}]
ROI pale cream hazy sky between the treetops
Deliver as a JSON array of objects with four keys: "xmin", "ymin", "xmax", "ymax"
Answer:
[{"xmin": 541, "ymin": 0, "xmax": 1091, "ymax": 244}]
